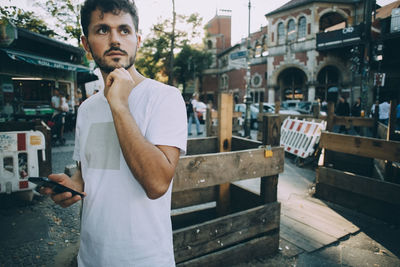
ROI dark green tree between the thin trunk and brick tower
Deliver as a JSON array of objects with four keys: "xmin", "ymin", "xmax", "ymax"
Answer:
[{"xmin": 174, "ymin": 45, "xmax": 212, "ymax": 93}]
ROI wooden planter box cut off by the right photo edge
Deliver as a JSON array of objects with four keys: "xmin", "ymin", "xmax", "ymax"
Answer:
[{"xmin": 316, "ymin": 132, "xmax": 400, "ymax": 224}]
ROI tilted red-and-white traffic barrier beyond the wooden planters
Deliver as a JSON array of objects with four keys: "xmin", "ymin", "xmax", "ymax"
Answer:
[{"xmin": 280, "ymin": 117, "xmax": 326, "ymax": 158}]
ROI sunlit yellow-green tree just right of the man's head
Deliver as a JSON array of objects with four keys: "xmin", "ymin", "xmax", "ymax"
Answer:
[{"xmin": 135, "ymin": 13, "xmax": 202, "ymax": 84}]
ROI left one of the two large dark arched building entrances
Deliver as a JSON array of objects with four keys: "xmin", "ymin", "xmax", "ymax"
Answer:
[{"xmin": 278, "ymin": 67, "xmax": 307, "ymax": 101}]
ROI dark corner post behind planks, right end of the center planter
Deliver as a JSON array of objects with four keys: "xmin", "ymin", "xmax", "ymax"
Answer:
[{"xmin": 260, "ymin": 116, "xmax": 281, "ymax": 203}]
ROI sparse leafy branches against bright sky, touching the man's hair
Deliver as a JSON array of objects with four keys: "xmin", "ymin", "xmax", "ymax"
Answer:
[{"xmin": 36, "ymin": 0, "xmax": 82, "ymax": 46}]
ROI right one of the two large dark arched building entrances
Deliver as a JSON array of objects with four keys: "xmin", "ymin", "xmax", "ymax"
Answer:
[{"xmin": 315, "ymin": 66, "xmax": 341, "ymax": 101}]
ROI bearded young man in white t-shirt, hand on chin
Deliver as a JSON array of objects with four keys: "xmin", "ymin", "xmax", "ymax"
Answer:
[{"xmin": 42, "ymin": 0, "xmax": 187, "ymax": 266}]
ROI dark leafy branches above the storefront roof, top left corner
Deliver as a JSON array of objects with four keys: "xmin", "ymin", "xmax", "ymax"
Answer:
[{"xmin": 0, "ymin": 6, "xmax": 57, "ymax": 37}]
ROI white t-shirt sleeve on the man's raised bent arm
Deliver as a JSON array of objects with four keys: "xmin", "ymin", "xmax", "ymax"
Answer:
[{"xmin": 145, "ymin": 87, "xmax": 187, "ymax": 155}]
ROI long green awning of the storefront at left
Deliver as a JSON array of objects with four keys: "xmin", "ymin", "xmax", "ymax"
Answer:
[{"xmin": 1, "ymin": 49, "xmax": 91, "ymax": 72}]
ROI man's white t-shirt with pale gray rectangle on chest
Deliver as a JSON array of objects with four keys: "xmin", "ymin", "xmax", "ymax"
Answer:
[{"xmin": 73, "ymin": 79, "xmax": 187, "ymax": 267}]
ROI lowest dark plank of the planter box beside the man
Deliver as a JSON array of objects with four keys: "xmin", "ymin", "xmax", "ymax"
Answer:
[{"xmin": 177, "ymin": 231, "xmax": 279, "ymax": 267}]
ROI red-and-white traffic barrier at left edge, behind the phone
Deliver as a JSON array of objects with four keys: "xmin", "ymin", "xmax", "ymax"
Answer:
[{"xmin": 0, "ymin": 131, "xmax": 46, "ymax": 194}]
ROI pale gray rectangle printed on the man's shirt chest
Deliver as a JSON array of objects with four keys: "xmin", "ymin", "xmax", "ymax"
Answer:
[{"xmin": 85, "ymin": 121, "xmax": 120, "ymax": 170}]
